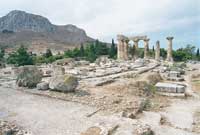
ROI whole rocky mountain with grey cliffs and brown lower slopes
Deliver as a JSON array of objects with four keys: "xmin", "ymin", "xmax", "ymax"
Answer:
[{"xmin": 0, "ymin": 10, "xmax": 93, "ymax": 53}]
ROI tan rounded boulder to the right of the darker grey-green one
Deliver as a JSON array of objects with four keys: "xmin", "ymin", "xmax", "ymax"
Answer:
[{"xmin": 49, "ymin": 75, "xmax": 78, "ymax": 92}]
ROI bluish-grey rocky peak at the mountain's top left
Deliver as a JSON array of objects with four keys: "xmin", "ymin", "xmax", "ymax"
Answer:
[{"xmin": 0, "ymin": 10, "xmax": 55, "ymax": 32}]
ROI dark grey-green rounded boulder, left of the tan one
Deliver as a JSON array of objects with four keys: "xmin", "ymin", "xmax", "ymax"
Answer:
[{"xmin": 16, "ymin": 66, "xmax": 42, "ymax": 88}]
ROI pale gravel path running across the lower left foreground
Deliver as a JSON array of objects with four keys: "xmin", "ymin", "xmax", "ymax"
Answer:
[{"xmin": 0, "ymin": 87, "xmax": 146, "ymax": 135}]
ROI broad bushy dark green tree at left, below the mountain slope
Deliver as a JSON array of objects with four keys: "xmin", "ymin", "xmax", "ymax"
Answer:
[{"xmin": 7, "ymin": 46, "xmax": 33, "ymax": 66}]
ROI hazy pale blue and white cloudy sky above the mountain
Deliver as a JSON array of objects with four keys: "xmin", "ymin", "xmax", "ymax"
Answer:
[{"xmin": 0, "ymin": 0, "xmax": 200, "ymax": 47}]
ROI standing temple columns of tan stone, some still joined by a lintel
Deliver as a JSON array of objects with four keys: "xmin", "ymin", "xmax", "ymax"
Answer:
[{"xmin": 117, "ymin": 35, "xmax": 173, "ymax": 62}]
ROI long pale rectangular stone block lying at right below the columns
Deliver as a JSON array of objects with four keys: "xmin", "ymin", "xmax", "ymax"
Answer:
[{"xmin": 155, "ymin": 82, "xmax": 185, "ymax": 93}]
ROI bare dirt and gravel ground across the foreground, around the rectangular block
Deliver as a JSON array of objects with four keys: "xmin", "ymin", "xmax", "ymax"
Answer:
[{"xmin": 0, "ymin": 62, "xmax": 200, "ymax": 135}]
